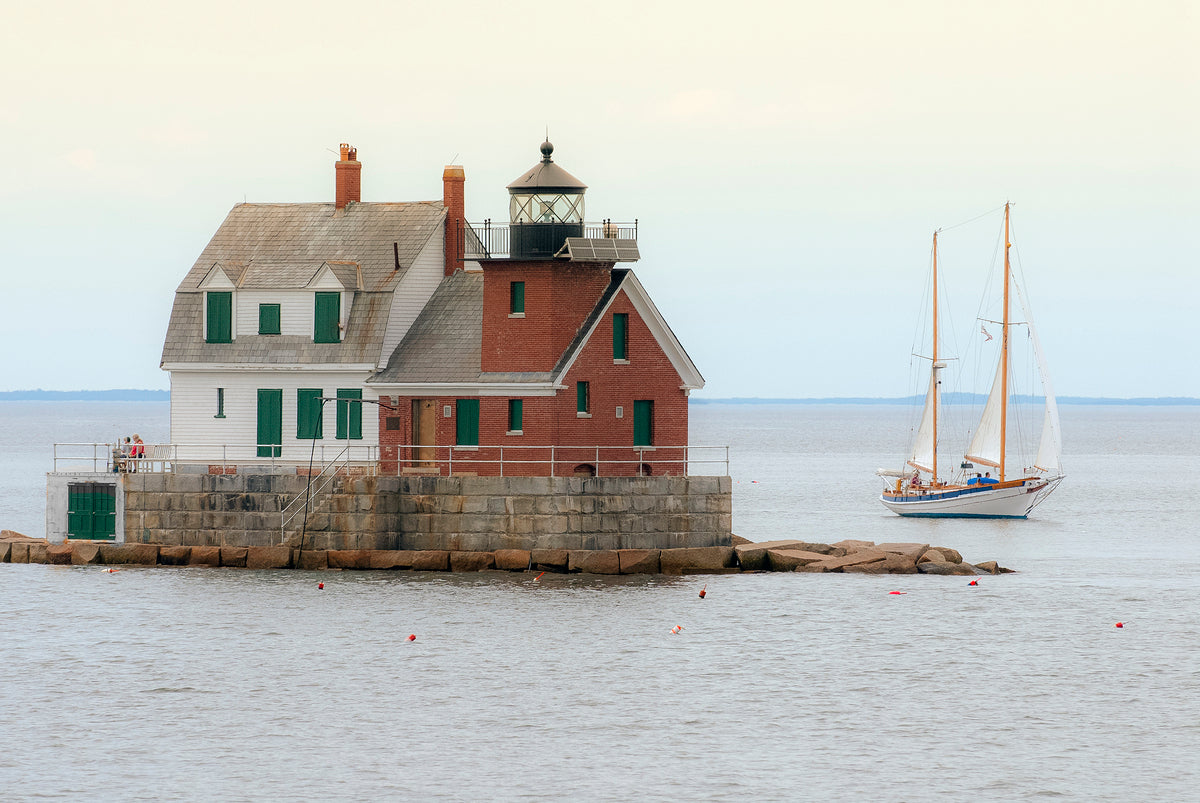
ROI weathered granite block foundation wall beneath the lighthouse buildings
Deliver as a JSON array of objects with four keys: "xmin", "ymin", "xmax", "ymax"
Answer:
[{"xmin": 114, "ymin": 473, "xmax": 732, "ymax": 552}]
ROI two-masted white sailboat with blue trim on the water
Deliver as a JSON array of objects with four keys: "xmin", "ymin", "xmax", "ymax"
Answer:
[{"xmin": 876, "ymin": 203, "xmax": 1063, "ymax": 519}]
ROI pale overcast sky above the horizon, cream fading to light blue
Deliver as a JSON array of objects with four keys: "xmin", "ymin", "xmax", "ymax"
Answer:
[{"xmin": 0, "ymin": 0, "xmax": 1200, "ymax": 397}]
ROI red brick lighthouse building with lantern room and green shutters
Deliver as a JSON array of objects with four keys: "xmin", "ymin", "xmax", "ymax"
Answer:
[{"xmin": 366, "ymin": 142, "xmax": 704, "ymax": 475}]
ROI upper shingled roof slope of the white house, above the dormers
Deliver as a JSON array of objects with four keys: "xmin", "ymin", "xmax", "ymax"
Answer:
[{"xmin": 176, "ymin": 202, "xmax": 445, "ymax": 292}]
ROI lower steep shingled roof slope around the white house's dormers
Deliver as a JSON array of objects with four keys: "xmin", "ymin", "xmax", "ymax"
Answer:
[{"xmin": 162, "ymin": 293, "xmax": 392, "ymax": 365}]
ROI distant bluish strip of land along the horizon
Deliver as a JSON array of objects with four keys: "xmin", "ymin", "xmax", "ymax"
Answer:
[{"xmin": 0, "ymin": 388, "xmax": 1200, "ymax": 406}]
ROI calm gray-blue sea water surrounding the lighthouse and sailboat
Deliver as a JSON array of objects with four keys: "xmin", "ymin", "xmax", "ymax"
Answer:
[{"xmin": 0, "ymin": 402, "xmax": 1200, "ymax": 801}]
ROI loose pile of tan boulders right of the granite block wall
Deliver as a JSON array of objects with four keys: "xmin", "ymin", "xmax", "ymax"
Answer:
[{"xmin": 733, "ymin": 537, "xmax": 1012, "ymax": 576}]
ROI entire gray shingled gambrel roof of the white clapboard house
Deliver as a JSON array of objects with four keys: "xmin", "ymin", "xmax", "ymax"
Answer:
[{"xmin": 162, "ymin": 202, "xmax": 445, "ymax": 365}]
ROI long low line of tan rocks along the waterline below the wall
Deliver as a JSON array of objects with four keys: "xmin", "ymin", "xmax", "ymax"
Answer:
[{"xmin": 0, "ymin": 531, "xmax": 1010, "ymax": 575}]
